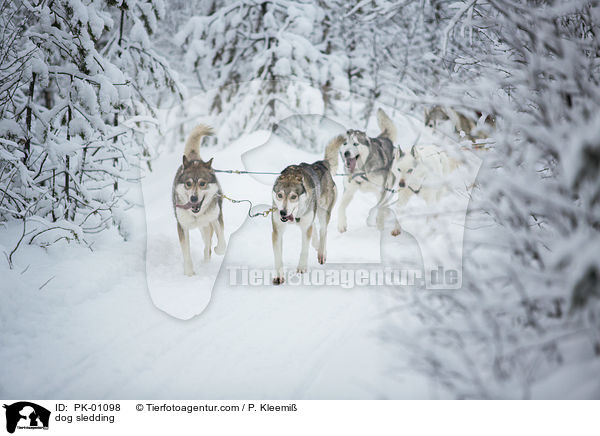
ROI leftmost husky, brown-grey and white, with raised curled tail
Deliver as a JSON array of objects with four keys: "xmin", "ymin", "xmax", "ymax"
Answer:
[{"xmin": 172, "ymin": 124, "xmax": 225, "ymax": 276}]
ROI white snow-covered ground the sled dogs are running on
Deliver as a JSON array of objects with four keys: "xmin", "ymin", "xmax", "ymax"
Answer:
[{"xmin": 0, "ymin": 109, "xmax": 596, "ymax": 399}]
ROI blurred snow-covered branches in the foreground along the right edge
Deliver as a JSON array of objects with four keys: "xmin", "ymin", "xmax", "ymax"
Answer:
[{"xmin": 378, "ymin": 0, "xmax": 600, "ymax": 398}]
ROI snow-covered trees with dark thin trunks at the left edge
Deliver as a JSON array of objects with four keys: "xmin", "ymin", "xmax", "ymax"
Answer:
[{"xmin": 0, "ymin": 0, "xmax": 174, "ymax": 261}]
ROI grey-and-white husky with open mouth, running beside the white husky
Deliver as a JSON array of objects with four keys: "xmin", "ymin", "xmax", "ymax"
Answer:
[{"xmin": 338, "ymin": 109, "xmax": 396, "ymax": 233}]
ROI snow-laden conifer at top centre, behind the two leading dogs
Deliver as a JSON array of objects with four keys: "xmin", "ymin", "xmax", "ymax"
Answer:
[{"xmin": 175, "ymin": 1, "xmax": 342, "ymax": 140}]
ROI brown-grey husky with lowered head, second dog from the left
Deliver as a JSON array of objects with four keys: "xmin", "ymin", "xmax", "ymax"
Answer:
[{"xmin": 271, "ymin": 135, "xmax": 345, "ymax": 285}]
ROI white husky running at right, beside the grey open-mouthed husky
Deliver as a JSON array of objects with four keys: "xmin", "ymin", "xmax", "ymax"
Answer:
[{"xmin": 376, "ymin": 145, "xmax": 459, "ymax": 236}]
